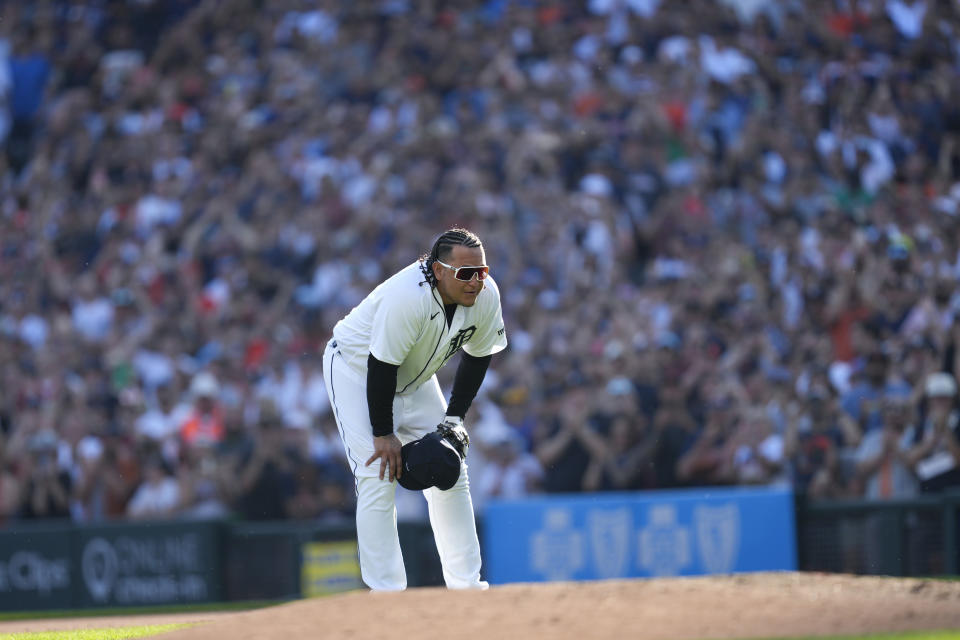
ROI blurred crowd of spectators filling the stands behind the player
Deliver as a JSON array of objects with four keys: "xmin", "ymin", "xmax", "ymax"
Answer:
[{"xmin": 0, "ymin": 0, "xmax": 960, "ymax": 522}]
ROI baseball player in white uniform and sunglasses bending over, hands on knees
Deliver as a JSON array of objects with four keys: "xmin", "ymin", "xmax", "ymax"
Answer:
[{"xmin": 323, "ymin": 229, "xmax": 507, "ymax": 591}]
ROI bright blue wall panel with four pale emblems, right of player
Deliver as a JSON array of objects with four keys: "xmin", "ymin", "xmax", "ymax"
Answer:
[{"xmin": 484, "ymin": 487, "xmax": 797, "ymax": 584}]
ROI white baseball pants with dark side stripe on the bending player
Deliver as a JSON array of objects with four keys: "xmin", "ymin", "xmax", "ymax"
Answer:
[{"xmin": 323, "ymin": 341, "xmax": 488, "ymax": 591}]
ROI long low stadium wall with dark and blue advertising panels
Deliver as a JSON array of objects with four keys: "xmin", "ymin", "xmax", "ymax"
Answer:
[{"xmin": 0, "ymin": 488, "xmax": 960, "ymax": 611}]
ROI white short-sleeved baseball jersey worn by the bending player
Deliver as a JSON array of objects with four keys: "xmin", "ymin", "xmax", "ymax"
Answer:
[{"xmin": 333, "ymin": 261, "xmax": 507, "ymax": 394}]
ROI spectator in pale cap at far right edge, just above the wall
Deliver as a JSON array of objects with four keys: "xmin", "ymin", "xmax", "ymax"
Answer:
[{"xmin": 909, "ymin": 371, "xmax": 960, "ymax": 493}]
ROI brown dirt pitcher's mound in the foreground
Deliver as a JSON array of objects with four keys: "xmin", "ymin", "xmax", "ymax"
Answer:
[{"xmin": 162, "ymin": 573, "xmax": 960, "ymax": 640}]
